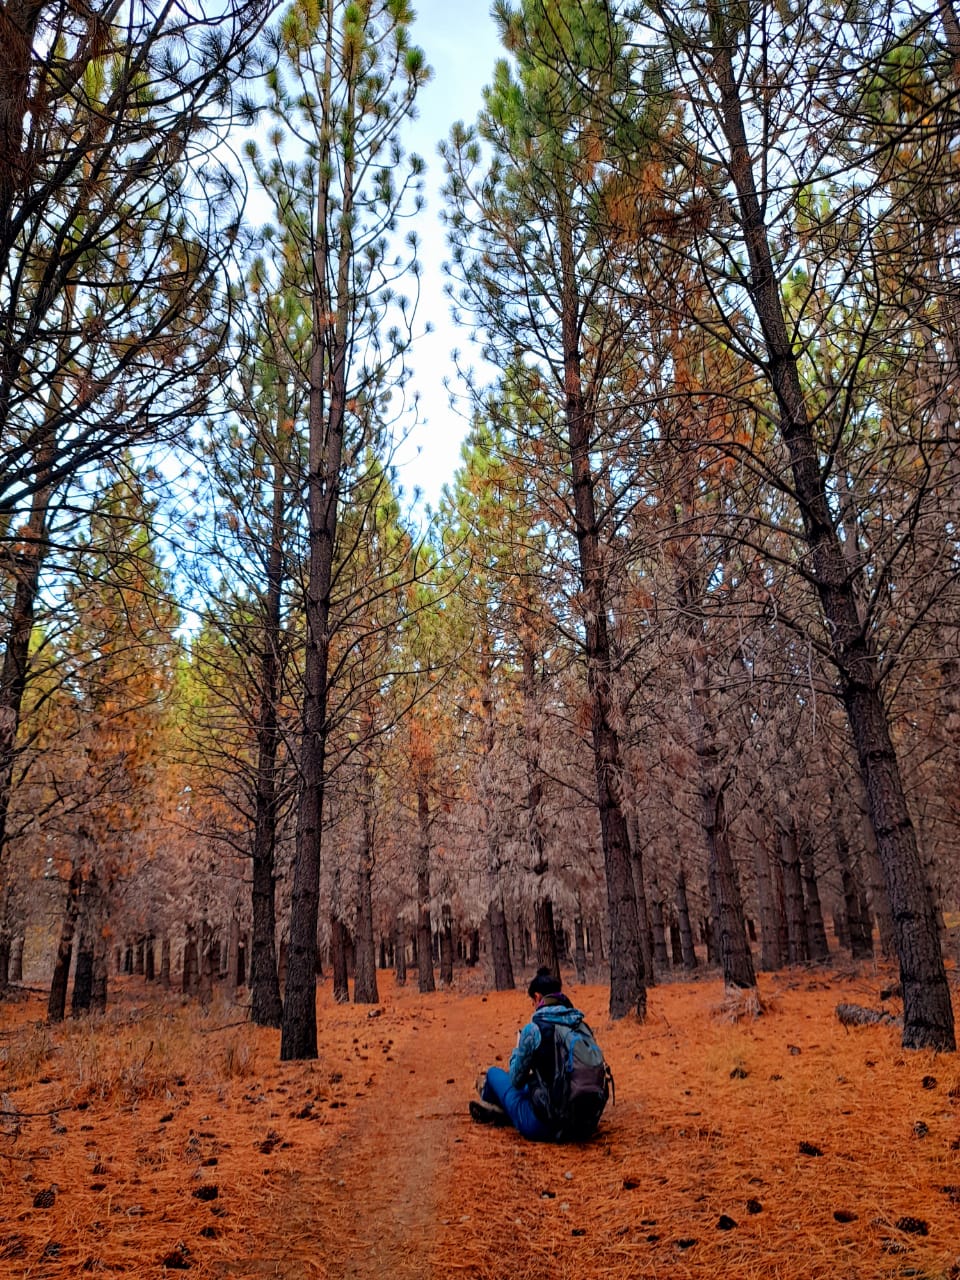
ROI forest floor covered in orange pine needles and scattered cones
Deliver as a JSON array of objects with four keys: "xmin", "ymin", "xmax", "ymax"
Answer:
[{"xmin": 0, "ymin": 961, "xmax": 960, "ymax": 1280}]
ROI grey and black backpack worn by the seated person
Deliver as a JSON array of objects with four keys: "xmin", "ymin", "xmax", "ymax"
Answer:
[{"xmin": 531, "ymin": 1021, "xmax": 613, "ymax": 1142}]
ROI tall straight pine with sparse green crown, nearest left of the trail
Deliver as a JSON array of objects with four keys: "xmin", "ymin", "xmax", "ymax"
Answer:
[{"xmin": 251, "ymin": 0, "xmax": 428, "ymax": 1060}]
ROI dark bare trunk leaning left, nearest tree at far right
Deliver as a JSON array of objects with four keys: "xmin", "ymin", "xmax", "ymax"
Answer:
[{"xmin": 708, "ymin": 12, "xmax": 956, "ymax": 1052}]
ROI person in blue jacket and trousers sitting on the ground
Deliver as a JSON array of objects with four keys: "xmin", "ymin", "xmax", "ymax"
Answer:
[{"xmin": 470, "ymin": 966, "xmax": 584, "ymax": 1142}]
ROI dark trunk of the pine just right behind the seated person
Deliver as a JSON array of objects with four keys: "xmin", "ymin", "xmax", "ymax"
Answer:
[{"xmin": 558, "ymin": 214, "xmax": 646, "ymax": 1019}]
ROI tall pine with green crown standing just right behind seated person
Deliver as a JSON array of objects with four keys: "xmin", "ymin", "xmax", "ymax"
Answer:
[{"xmin": 444, "ymin": 0, "xmax": 645, "ymax": 1016}]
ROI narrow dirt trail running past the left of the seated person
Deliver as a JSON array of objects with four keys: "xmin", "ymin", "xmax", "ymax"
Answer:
[{"xmin": 223, "ymin": 992, "xmax": 520, "ymax": 1280}]
